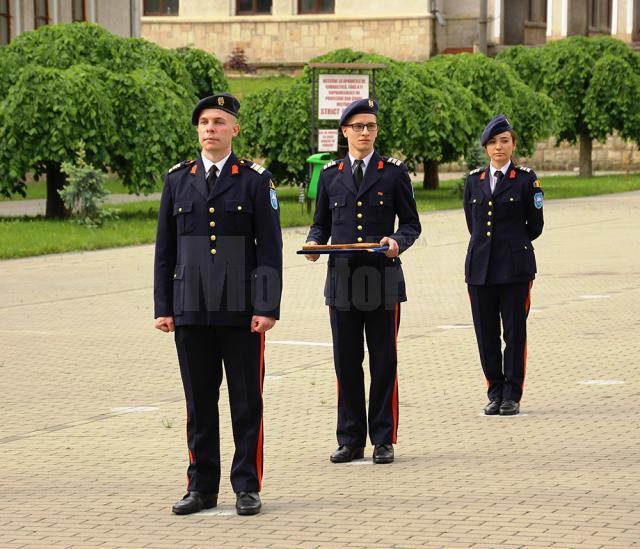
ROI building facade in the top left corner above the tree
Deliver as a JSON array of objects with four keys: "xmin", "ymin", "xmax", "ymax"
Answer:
[{"xmin": 0, "ymin": 0, "xmax": 142, "ymax": 45}]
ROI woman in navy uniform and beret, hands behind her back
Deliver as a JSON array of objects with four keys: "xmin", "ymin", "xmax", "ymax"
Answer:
[{"xmin": 464, "ymin": 115, "xmax": 544, "ymax": 415}]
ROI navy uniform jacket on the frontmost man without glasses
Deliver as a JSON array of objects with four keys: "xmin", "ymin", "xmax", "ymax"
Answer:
[{"xmin": 154, "ymin": 153, "xmax": 282, "ymax": 326}]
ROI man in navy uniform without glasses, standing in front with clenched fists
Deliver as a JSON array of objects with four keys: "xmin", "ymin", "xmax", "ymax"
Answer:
[{"xmin": 154, "ymin": 93, "xmax": 282, "ymax": 515}]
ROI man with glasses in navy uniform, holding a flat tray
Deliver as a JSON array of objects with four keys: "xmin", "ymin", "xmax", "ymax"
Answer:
[{"xmin": 306, "ymin": 99, "xmax": 421, "ymax": 463}]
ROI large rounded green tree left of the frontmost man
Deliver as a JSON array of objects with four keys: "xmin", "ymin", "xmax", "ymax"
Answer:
[{"xmin": 0, "ymin": 23, "xmax": 226, "ymax": 217}]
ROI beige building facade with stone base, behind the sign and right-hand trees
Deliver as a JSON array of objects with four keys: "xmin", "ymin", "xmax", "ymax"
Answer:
[{"xmin": 140, "ymin": 0, "xmax": 640, "ymax": 65}]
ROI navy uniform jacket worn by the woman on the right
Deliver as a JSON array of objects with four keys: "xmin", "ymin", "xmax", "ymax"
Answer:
[{"xmin": 464, "ymin": 162, "xmax": 544, "ymax": 285}]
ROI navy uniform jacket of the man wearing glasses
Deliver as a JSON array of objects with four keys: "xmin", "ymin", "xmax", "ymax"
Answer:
[{"xmin": 307, "ymin": 152, "xmax": 421, "ymax": 306}]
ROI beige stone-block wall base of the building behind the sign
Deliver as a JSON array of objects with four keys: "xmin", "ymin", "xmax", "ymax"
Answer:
[{"xmin": 140, "ymin": 15, "xmax": 430, "ymax": 64}]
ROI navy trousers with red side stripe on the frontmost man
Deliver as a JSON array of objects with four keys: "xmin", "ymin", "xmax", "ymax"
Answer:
[{"xmin": 175, "ymin": 326, "xmax": 264, "ymax": 494}]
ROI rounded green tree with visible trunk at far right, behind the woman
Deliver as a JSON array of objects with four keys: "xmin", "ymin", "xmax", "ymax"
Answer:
[{"xmin": 500, "ymin": 36, "xmax": 640, "ymax": 177}]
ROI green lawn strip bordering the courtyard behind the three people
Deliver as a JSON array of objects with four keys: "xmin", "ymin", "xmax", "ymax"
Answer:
[{"xmin": 0, "ymin": 174, "xmax": 640, "ymax": 259}]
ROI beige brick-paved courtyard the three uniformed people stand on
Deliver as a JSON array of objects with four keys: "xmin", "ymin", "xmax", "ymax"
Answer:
[{"xmin": 0, "ymin": 192, "xmax": 640, "ymax": 548}]
